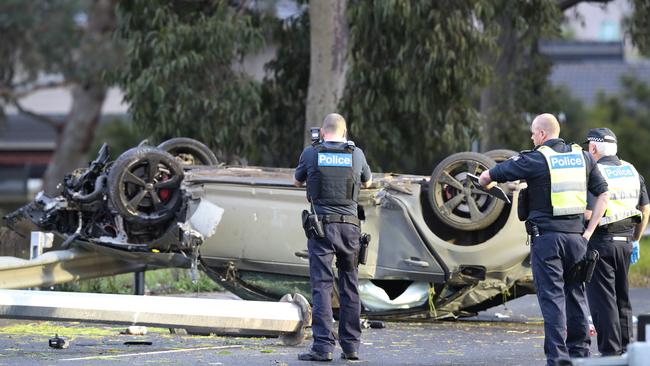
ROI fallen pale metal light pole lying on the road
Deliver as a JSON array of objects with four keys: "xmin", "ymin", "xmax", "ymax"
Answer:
[{"xmin": 0, "ymin": 290, "xmax": 311, "ymax": 345}]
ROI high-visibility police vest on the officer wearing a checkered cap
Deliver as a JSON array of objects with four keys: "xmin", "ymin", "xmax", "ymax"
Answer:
[{"xmin": 598, "ymin": 160, "xmax": 641, "ymax": 226}]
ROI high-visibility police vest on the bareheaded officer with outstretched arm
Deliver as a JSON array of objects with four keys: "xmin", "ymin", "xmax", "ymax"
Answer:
[{"xmin": 537, "ymin": 144, "xmax": 587, "ymax": 216}]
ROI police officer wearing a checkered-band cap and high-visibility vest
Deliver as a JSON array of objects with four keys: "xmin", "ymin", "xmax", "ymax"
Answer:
[{"xmin": 585, "ymin": 128, "xmax": 650, "ymax": 356}]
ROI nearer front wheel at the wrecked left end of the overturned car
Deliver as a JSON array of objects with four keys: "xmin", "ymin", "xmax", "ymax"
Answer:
[{"xmin": 108, "ymin": 146, "xmax": 183, "ymax": 224}]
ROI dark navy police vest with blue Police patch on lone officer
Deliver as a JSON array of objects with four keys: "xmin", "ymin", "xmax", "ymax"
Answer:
[{"xmin": 307, "ymin": 143, "xmax": 361, "ymax": 206}]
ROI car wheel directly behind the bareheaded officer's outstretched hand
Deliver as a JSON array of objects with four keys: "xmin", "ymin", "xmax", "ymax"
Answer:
[{"xmin": 429, "ymin": 152, "xmax": 505, "ymax": 231}]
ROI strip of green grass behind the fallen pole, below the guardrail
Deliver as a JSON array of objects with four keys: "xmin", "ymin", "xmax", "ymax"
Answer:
[{"xmin": 55, "ymin": 268, "xmax": 223, "ymax": 295}]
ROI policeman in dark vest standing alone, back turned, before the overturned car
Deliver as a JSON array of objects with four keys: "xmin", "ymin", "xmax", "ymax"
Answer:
[{"xmin": 294, "ymin": 113, "xmax": 372, "ymax": 361}]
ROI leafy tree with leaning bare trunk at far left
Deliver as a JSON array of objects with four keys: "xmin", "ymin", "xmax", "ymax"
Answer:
[{"xmin": 0, "ymin": 0, "xmax": 119, "ymax": 195}]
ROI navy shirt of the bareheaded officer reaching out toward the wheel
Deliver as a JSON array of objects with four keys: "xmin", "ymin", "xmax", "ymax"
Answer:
[{"xmin": 490, "ymin": 139, "xmax": 607, "ymax": 233}]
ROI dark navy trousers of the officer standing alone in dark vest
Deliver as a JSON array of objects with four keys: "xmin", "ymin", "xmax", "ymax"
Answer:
[{"xmin": 307, "ymin": 223, "xmax": 361, "ymax": 353}]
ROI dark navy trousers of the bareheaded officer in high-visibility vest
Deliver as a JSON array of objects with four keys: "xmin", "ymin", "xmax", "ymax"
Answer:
[{"xmin": 531, "ymin": 231, "xmax": 591, "ymax": 366}]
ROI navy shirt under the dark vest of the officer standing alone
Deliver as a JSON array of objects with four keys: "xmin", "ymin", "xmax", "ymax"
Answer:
[{"xmin": 294, "ymin": 141, "xmax": 372, "ymax": 216}]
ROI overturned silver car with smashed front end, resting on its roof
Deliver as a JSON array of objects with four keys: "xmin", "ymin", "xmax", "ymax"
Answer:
[{"xmin": 5, "ymin": 138, "xmax": 534, "ymax": 318}]
